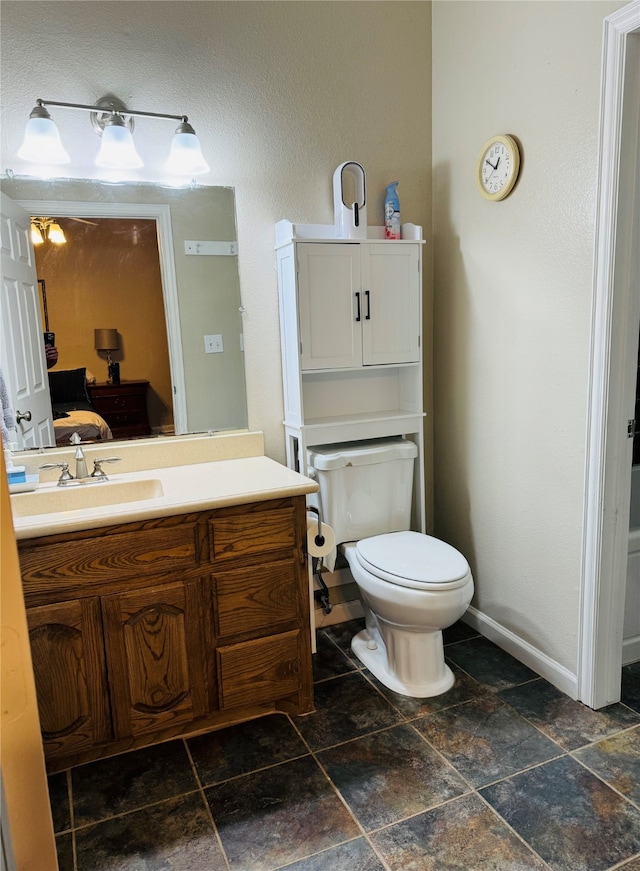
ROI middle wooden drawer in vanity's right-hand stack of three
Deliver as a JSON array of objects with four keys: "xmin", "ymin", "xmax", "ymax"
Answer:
[{"xmin": 214, "ymin": 560, "xmax": 300, "ymax": 635}]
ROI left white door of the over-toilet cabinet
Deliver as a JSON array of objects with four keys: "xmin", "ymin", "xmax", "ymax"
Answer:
[{"xmin": 296, "ymin": 243, "xmax": 363, "ymax": 370}]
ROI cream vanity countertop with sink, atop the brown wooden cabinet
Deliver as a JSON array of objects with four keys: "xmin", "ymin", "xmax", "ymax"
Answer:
[{"xmin": 11, "ymin": 456, "xmax": 318, "ymax": 539}]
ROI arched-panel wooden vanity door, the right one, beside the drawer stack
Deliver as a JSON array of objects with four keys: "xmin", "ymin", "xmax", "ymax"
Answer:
[{"xmin": 102, "ymin": 581, "xmax": 212, "ymax": 739}]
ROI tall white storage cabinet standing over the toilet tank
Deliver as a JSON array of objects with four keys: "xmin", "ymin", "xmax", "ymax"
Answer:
[{"xmin": 276, "ymin": 221, "xmax": 426, "ymax": 532}]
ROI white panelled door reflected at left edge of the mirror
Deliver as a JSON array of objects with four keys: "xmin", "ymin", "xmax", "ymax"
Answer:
[{"xmin": 0, "ymin": 194, "xmax": 55, "ymax": 449}]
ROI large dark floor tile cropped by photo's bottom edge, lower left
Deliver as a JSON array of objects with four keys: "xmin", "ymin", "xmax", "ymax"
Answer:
[{"xmin": 76, "ymin": 792, "xmax": 227, "ymax": 871}]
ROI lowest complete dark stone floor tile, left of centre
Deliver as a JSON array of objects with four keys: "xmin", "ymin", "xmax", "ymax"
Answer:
[{"xmin": 205, "ymin": 756, "xmax": 360, "ymax": 871}]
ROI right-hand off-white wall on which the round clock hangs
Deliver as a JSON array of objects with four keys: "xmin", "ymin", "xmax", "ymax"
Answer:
[{"xmin": 433, "ymin": 0, "xmax": 624, "ymax": 689}]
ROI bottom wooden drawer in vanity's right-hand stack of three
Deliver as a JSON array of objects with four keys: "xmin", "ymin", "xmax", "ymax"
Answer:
[{"xmin": 217, "ymin": 630, "xmax": 301, "ymax": 708}]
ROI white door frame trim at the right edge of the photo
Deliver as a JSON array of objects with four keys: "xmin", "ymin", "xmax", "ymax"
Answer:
[{"xmin": 578, "ymin": 0, "xmax": 640, "ymax": 708}]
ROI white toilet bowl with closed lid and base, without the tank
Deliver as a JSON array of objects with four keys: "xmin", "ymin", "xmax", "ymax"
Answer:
[{"xmin": 343, "ymin": 531, "xmax": 473, "ymax": 698}]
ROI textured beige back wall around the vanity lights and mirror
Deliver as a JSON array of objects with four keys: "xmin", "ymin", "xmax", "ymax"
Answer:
[{"xmin": 1, "ymin": 0, "xmax": 431, "ymax": 498}]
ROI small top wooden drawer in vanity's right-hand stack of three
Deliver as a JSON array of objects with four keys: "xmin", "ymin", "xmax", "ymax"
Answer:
[{"xmin": 209, "ymin": 506, "xmax": 296, "ymax": 562}]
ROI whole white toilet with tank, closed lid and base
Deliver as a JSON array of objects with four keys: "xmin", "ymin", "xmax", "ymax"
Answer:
[{"xmin": 307, "ymin": 438, "xmax": 473, "ymax": 698}]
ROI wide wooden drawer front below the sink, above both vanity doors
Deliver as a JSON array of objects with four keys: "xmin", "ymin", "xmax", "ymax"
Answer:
[{"xmin": 19, "ymin": 523, "xmax": 199, "ymax": 604}]
